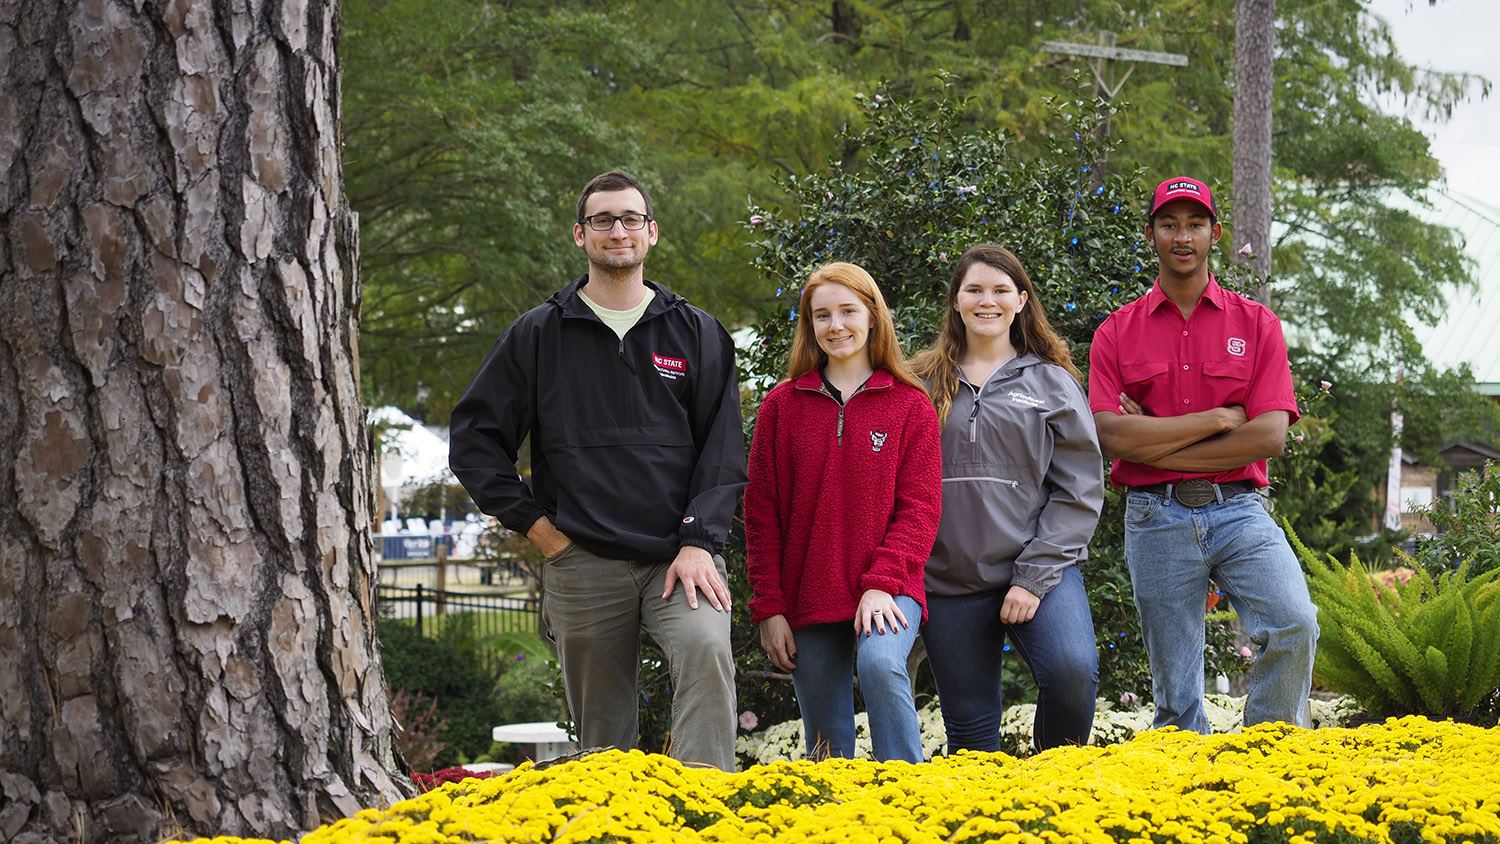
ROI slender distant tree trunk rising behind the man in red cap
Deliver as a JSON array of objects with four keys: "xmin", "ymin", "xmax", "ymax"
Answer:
[{"xmin": 1230, "ymin": 0, "xmax": 1277, "ymax": 304}]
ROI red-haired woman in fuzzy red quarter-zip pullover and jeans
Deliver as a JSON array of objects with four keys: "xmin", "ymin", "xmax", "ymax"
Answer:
[{"xmin": 744, "ymin": 262, "xmax": 942, "ymax": 762}]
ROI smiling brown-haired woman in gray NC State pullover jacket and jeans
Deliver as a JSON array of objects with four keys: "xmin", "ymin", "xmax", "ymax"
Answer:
[{"xmin": 914, "ymin": 244, "xmax": 1104, "ymax": 753}]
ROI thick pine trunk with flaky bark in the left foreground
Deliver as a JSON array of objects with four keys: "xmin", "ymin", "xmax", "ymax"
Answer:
[{"xmin": 0, "ymin": 0, "xmax": 401, "ymax": 843}]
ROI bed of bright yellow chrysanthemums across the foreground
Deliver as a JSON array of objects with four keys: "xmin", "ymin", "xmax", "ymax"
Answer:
[{"xmin": 178, "ymin": 717, "xmax": 1500, "ymax": 844}]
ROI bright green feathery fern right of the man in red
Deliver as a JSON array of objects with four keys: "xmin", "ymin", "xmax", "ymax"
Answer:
[{"xmin": 1289, "ymin": 531, "xmax": 1500, "ymax": 718}]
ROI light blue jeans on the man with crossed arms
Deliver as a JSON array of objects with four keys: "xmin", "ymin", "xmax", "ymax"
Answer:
[{"xmin": 1125, "ymin": 492, "xmax": 1319, "ymax": 733}]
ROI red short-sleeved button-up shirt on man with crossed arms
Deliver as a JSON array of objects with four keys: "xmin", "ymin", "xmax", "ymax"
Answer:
[{"xmin": 1089, "ymin": 276, "xmax": 1298, "ymax": 486}]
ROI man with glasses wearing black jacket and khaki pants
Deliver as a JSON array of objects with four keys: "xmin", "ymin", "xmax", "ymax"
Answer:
[{"xmin": 449, "ymin": 171, "xmax": 746, "ymax": 771}]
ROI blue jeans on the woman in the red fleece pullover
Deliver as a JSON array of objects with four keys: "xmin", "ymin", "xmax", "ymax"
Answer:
[{"xmin": 792, "ymin": 595, "xmax": 923, "ymax": 762}]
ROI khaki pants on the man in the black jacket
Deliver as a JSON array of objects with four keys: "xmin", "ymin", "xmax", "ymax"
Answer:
[{"xmin": 542, "ymin": 544, "xmax": 735, "ymax": 771}]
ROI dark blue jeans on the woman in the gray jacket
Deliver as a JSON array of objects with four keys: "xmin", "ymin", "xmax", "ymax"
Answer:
[{"xmin": 923, "ymin": 565, "xmax": 1100, "ymax": 753}]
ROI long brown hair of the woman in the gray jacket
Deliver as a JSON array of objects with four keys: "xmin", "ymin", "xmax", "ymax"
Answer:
[{"xmin": 912, "ymin": 243, "xmax": 1083, "ymax": 423}]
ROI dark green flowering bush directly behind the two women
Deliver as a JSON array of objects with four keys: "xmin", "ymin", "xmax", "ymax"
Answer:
[{"xmin": 737, "ymin": 85, "xmax": 1244, "ymax": 712}]
